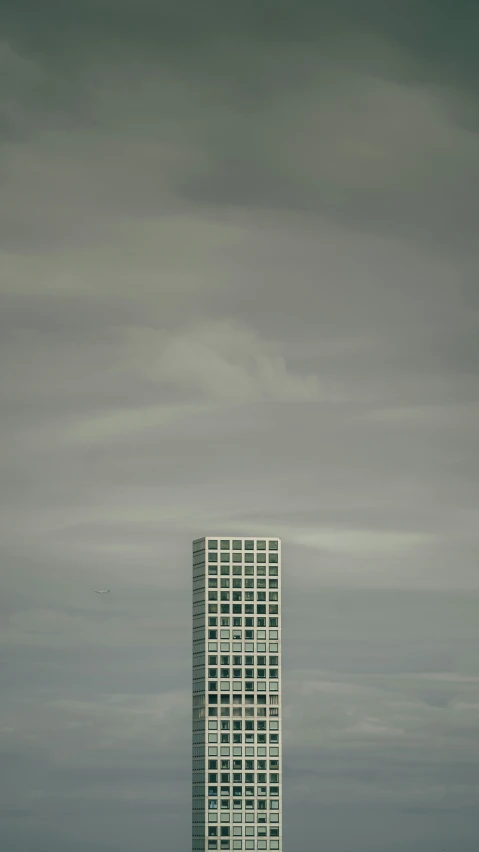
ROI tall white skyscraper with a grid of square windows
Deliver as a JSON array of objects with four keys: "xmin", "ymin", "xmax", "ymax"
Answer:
[{"xmin": 193, "ymin": 536, "xmax": 282, "ymax": 850}]
